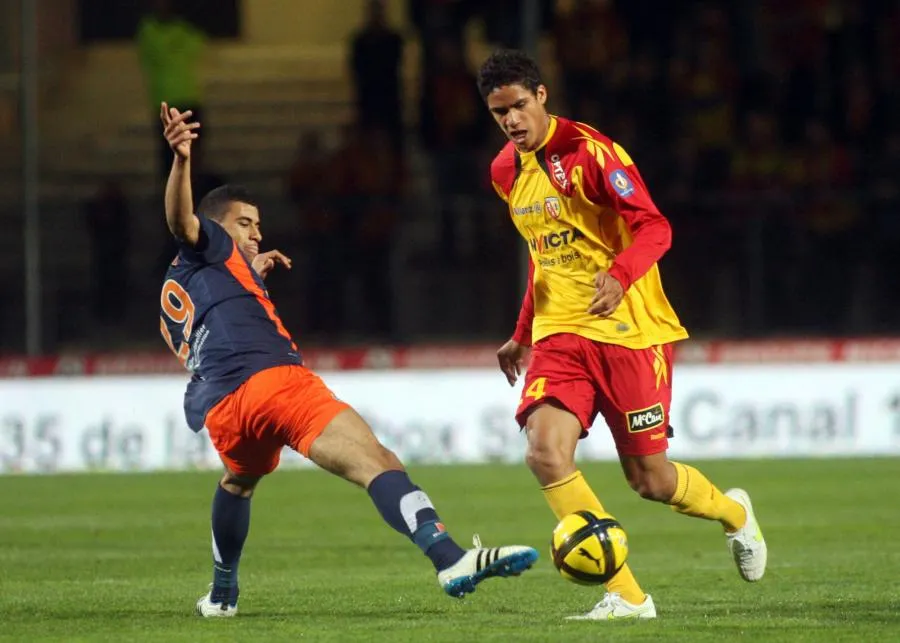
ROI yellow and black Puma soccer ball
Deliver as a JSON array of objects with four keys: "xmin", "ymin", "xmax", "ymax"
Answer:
[{"xmin": 550, "ymin": 511, "xmax": 628, "ymax": 585}]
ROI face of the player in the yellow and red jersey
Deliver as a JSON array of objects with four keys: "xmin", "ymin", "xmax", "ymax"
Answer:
[{"xmin": 487, "ymin": 84, "xmax": 549, "ymax": 152}]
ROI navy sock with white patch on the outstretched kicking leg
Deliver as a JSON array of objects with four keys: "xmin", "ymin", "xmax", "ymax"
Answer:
[{"xmin": 368, "ymin": 471, "xmax": 465, "ymax": 571}]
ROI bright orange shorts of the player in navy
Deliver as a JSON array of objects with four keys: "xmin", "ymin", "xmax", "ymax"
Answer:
[{"xmin": 206, "ymin": 365, "xmax": 350, "ymax": 476}]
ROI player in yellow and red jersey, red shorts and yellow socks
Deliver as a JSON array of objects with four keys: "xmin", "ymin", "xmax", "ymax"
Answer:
[{"xmin": 478, "ymin": 50, "xmax": 767, "ymax": 620}]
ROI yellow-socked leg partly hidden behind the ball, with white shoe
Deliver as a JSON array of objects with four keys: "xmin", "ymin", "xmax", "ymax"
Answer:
[{"xmin": 525, "ymin": 399, "xmax": 656, "ymax": 618}]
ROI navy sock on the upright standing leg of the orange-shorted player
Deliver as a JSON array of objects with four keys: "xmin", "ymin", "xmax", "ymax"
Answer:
[{"xmin": 212, "ymin": 485, "xmax": 250, "ymax": 599}]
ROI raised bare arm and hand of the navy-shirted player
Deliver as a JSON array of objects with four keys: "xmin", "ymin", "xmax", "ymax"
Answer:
[{"xmin": 159, "ymin": 103, "xmax": 200, "ymax": 246}]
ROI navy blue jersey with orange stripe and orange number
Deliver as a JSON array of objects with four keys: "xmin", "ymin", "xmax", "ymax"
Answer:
[{"xmin": 159, "ymin": 217, "xmax": 302, "ymax": 431}]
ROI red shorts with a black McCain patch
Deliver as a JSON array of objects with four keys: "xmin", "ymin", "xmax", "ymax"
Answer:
[{"xmin": 516, "ymin": 333, "xmax": 672, "ymax": 456}]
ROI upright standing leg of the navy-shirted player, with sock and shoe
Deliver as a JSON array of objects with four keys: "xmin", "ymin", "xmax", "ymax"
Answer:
[{"xmin": 197, "ymin": 465, "xmax": 261, "ymax": 617}]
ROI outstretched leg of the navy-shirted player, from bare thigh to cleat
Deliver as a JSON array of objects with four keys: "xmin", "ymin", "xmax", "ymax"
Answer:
[{"xmin": 308, "ymin": 408, "xmax": 538, "ymax": 597}]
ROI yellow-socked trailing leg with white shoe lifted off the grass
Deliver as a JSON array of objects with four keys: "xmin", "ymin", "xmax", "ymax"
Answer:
[{"xmin": 620, "ymin": 452, "xmax": 768, "ymax": 582}]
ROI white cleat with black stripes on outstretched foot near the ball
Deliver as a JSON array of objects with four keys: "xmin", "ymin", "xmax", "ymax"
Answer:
[{"xmin": 438, "ymin": 535, "xmax": 538, "ymax": 598}]
